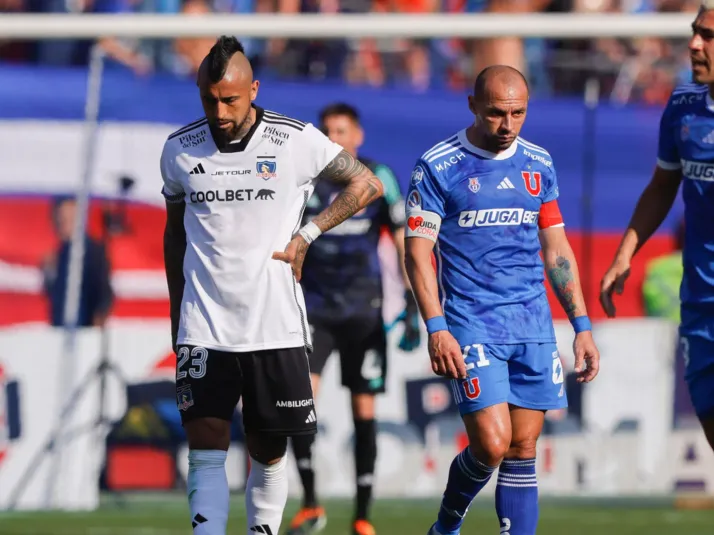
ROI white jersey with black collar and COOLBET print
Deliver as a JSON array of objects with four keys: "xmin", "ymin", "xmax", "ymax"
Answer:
[{"xmin": 161, "ymin": 106, "xmax": 342, "ymax": 352}]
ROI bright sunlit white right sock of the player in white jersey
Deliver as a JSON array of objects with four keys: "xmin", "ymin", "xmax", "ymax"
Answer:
[{"xmin": 245, "ymin": 455, "xmax": 288, "ymax": 535}]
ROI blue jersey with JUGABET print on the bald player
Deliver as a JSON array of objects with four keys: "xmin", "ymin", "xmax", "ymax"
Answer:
[{"xmin": 406, "ymin": 130, "xmax": 562, "ymax": 346}]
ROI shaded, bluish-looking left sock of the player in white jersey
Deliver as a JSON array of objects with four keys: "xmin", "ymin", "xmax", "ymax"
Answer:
[{"xmin": 186, "ymin": 450, "xmax": 230, "ymax": 535}]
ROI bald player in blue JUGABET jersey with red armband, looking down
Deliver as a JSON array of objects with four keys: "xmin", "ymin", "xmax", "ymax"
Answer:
[{"xmin": 406, "ymin": 66, "xmax": 599, "ymax": 535}]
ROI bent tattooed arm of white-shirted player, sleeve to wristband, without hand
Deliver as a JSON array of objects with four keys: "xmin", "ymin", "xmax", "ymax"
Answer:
[{"xmin": 314, "ymin": 150, "xmax": 382, "ymax": 231}]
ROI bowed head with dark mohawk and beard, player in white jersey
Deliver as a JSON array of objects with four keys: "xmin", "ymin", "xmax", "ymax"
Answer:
[{"xmin": 197, "ymin": 36, "xmax": 259, "ymax": 145}]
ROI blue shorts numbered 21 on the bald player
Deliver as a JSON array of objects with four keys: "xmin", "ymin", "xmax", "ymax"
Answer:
[{"xmin": 451, "ymin": 343, "xmax": 568, "ymax": 415}]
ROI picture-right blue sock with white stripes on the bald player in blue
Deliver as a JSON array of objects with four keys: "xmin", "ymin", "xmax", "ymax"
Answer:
[{"xmin": 496, "ymin": 459, "xmax": 538, "ymax": 535}]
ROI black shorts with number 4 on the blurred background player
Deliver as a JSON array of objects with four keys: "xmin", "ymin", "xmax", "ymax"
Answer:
[{"xmin": 310, "ymin": 315, "xmax": 387, "ymax": 394}]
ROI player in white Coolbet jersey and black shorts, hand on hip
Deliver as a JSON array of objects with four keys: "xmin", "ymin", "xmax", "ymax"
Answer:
[{"xmin": 161, "ymin": 37, "xmax": 383, "ymax": 535}]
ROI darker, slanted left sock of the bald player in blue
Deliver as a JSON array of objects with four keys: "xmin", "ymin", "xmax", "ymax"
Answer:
[{"xmin": 436, "ymin": 448, "xmax": 496, "ymax": 535}]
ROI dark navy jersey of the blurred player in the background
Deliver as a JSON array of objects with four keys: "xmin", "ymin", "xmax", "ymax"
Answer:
[{"xmin": 300, "ymin": 158, "xmax": 404, "ymax": 322}]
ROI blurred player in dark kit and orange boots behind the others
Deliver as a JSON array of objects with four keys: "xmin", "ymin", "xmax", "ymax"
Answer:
[{"xmin": 288, "ymin": 103, "xmax": 419, "ymax": 535}]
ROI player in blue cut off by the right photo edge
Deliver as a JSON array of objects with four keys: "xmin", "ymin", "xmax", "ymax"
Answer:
[{"xmin": 600, "ymin": 0, "xmax": 714, "ymax": 456}]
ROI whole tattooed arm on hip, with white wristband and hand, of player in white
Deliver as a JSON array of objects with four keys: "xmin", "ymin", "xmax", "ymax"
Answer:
[{"xmin": 273, "ymin": 150, "xmax": 384, "ymax": 281}]
